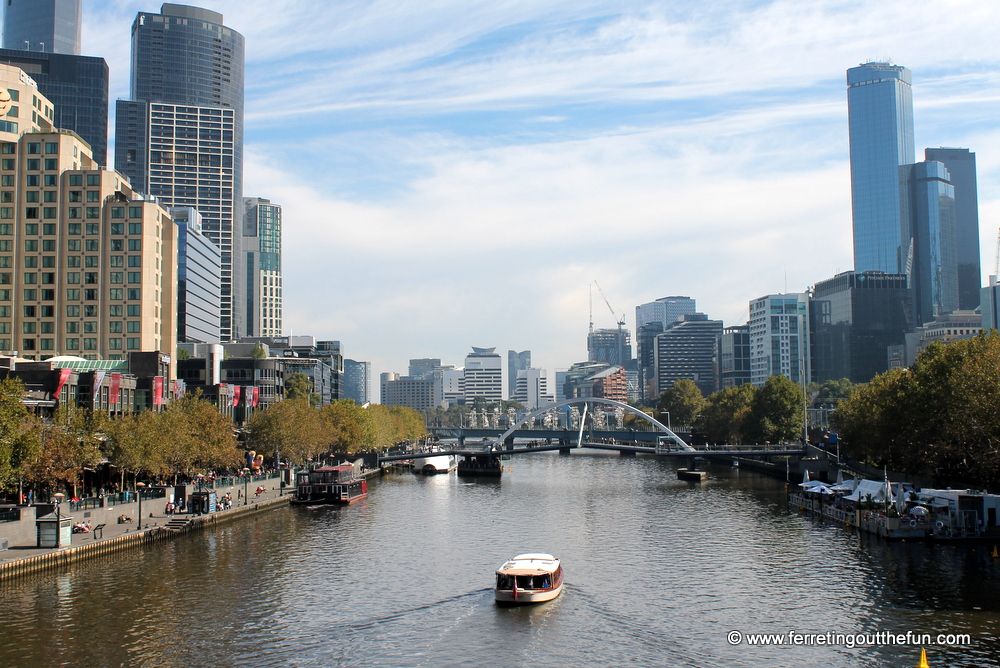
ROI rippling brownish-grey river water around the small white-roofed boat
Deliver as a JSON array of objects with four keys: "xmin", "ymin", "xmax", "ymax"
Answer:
[{"xmin": 0, "ymin": 453, "xmax": 1000, "ymax": 668}]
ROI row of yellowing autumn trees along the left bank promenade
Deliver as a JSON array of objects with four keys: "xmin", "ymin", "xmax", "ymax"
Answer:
[{"xmin": 0, "ymin": 378, "xmax": 426, "ymax": 496}]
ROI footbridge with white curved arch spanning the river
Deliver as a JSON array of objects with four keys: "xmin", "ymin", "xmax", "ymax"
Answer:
[{"xmin": 379, "ymin": 397, "xmax": 805, "ymax": 462}]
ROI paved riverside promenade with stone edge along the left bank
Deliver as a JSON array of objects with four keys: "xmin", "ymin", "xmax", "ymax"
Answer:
[{"xmin": 0, "ymin": 478, "xmax": 292, "ymax": 578}]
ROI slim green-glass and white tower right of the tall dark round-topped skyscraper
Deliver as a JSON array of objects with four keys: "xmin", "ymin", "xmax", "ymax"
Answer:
[{"xmin": 242, "ymin": 197, "xmax": 282, "ymax": 336}]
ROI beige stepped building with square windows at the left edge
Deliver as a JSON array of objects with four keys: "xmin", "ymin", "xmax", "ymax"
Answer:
[{"xmin": 0, "ymin": 65, "xmax": 177, "ymax": 359}]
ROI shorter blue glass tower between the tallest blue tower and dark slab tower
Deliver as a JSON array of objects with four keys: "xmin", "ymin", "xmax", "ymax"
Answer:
[{"xmin": 900, "ymin": 162, "xmax": 958, "ymax": 326}]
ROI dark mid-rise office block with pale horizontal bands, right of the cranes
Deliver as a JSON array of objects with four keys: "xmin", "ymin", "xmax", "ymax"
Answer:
[{"xmin": 655, "ymin": 313, "xmax": 722, "ymax": 397}]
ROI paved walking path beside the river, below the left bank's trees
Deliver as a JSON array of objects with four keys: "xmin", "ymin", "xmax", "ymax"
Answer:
[{"xmin": 0, "ymin": 478, "xmax": 294, "ymax": 565}]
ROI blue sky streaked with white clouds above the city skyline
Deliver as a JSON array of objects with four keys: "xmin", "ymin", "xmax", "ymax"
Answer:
[{"xmin": 74, "ymin": 0, "xmax": 1000, "ymax": 392}]
